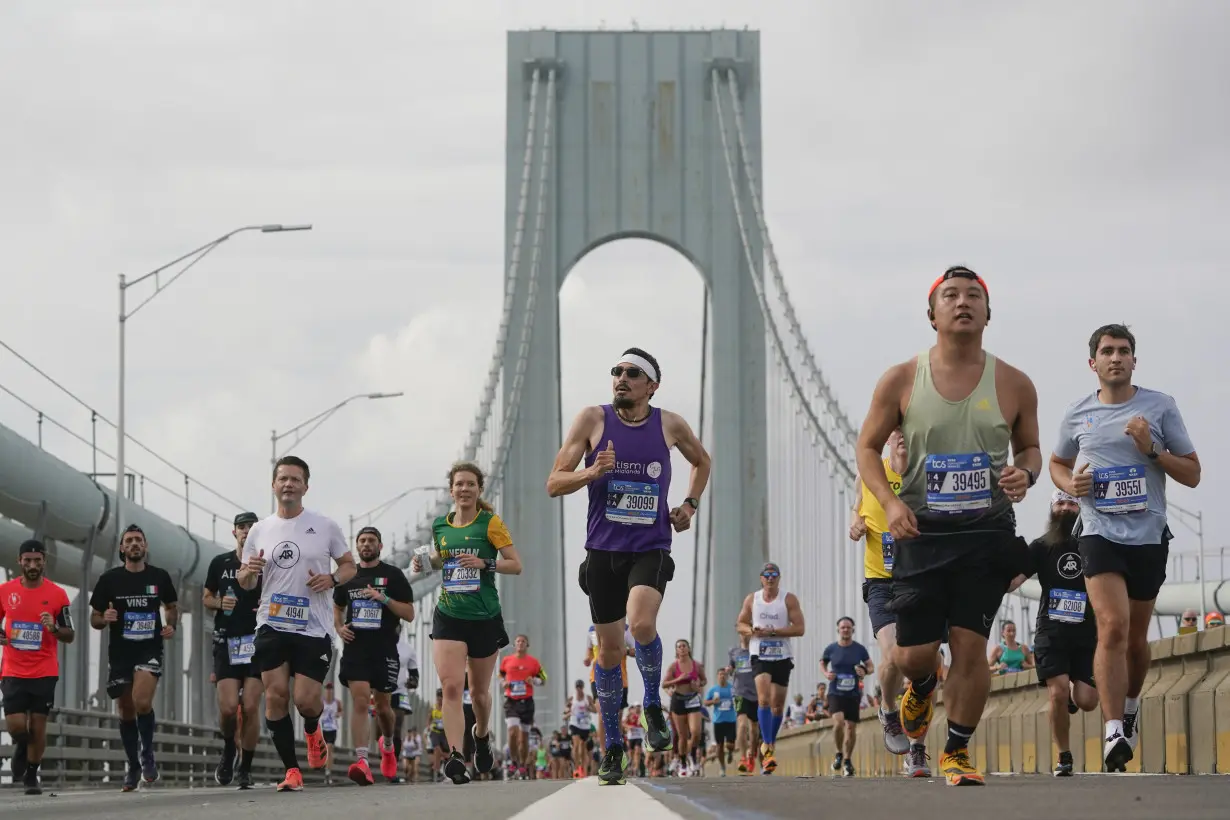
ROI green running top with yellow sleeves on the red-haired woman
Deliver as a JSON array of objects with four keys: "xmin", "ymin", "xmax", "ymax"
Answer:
[{"xmin": 432, "ymin": 510, "xmax": 513, "ymax": 621}]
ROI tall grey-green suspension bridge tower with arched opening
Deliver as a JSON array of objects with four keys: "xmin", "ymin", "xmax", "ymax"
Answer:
[{"xmin": 502, "ymin": 31, "xmax": 769, "ymax": 712}]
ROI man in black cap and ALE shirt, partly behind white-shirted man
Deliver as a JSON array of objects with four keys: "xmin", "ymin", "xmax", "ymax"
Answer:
[{"xmin": 202, "ymin": 513, "xmax": 263, "ymax": 789}]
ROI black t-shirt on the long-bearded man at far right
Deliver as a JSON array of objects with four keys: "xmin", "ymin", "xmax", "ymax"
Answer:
[{"xmin": 1030, "ymin": 537, "xmax": 1097, "ymax": 643}]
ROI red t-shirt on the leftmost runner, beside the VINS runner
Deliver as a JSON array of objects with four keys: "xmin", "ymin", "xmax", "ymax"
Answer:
[{"xmin": 0, "ymin": 578, "xmax": 73, "ymax": 679}]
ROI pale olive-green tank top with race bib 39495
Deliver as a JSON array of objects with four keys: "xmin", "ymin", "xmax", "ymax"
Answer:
[{"xmin": 900, "ymin": 350, "xmax": 1015, "ymax": 532}]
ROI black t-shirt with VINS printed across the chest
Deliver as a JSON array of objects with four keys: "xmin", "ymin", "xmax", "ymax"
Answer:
[{"xmin": 90, "ymin": 564, "xmax": 180, "ymax": 656}]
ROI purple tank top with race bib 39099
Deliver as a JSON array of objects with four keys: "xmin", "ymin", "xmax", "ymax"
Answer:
[{"xmin": 585, "ymin": 404, "xmax": 670, "ymax": 552}]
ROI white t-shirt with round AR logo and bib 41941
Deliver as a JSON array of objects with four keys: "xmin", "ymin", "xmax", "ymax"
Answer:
[{"xmin": 242, "ymin": 510, "xmax": 349, "ymax": 638}]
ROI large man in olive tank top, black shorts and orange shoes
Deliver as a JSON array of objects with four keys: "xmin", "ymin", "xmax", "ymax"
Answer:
[{"xmin": 857, "ymin": 267, "xmax": 1042, "ymax": 786}]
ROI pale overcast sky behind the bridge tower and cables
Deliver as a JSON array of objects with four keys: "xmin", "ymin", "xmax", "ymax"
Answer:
[{"xmin": 0, "ymin": 0, "xmax": 1230, "ymax": 698}]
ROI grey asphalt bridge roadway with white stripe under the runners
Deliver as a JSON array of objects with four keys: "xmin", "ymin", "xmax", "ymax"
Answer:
[{"xmin": 0, "ymin": 775, "xmax": 1230, "ymax": 820}]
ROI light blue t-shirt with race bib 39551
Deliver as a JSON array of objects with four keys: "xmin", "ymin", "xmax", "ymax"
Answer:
[{"xmin": 1055, "ymin": 387, "xmax": 1196, "ymax": 545}]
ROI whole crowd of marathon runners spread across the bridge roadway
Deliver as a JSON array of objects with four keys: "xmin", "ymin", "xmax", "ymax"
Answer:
[{"xmin": 0, "ymin": 267, "xmax": 1200, "ymax": 792}]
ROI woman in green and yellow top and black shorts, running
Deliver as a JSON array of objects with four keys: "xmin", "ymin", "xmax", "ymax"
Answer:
[{"xmin": 412, "ymin": 461, "xmax": 522, "ymax": 786}]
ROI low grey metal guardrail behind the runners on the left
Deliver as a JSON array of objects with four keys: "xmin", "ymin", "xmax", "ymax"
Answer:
[{"xmin": 0, "ymin": 708, "xmax": 393, "ymax": 789}]
